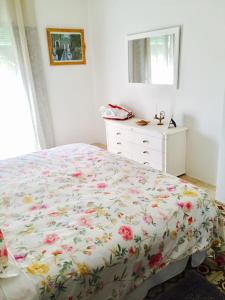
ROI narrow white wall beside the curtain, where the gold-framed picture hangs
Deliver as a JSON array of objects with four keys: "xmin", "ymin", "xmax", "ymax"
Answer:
[{"xmin": 26, "ymin": 0, "xmax": 95, "ymax": 145}]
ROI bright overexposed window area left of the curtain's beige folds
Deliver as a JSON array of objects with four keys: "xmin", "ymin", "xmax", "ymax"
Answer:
[{"xmin": 0, "ymin": 23, "xmax": 37, "ymax": 159}]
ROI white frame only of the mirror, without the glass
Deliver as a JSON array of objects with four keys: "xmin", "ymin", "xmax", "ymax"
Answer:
[{"xmin": 127, "ymin": 26, "xmax": 181, "ymax": 88}]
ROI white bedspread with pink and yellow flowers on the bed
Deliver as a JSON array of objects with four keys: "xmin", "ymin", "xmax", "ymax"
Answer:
[{"xmin": 0, "ymin": 144, "xmax": 216, "ymax": 300}]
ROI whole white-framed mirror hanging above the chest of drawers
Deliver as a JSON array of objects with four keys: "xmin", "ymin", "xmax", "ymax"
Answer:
[{"xmin": 127, "ymin": 26, "xmax": 180, "ymax": 87}]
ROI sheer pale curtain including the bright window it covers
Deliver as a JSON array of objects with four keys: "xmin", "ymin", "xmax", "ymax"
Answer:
[{"xmin": 0, "ymin": 0, "xmax": 54, "ymax": 159}]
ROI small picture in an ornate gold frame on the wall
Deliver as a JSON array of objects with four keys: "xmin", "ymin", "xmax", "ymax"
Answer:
[{"xmin": 47, "ymin": 28, "xmax": 86, "ymax": 66}]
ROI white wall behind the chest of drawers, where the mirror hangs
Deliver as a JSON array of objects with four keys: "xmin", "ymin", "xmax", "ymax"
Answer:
[{"xmin": 89, "ymin": 0, "xmax": 225, "ymax": 184}]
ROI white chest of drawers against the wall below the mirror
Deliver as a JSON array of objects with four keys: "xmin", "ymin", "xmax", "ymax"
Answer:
[{"xmin": 105, "ymin": 118, "xmax": 187, "ymax": 176}]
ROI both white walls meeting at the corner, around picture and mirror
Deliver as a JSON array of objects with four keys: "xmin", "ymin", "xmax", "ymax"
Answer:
[{"xmin": 20, "ymin": 0, "xmax": 225, "ymax": 184}]
